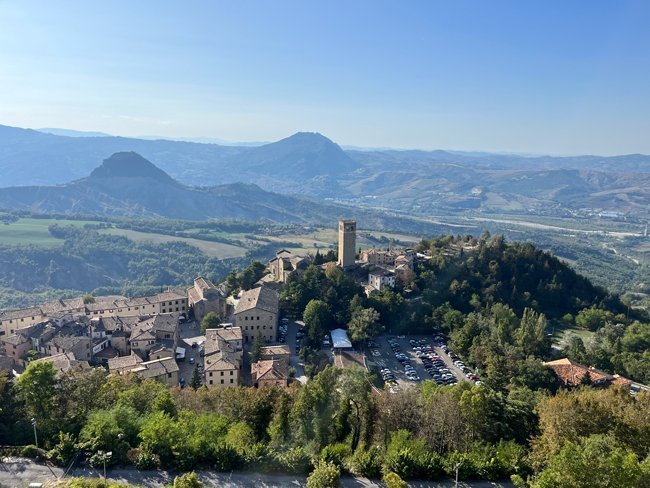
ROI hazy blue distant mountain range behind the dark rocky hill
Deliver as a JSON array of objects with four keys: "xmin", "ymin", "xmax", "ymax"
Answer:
[{"xmin": 0, "ymin": 126, "xmax": 650, "ymax": 218}]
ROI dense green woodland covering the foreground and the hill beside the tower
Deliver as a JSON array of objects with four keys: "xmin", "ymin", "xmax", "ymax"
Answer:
[{"xmin": 0, "ymin": 235, "xmax": 650, "ymax": 487}]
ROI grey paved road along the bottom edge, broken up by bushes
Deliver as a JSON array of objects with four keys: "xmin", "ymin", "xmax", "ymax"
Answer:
[{"xmin": 0, "ymin": 458, "xmax": 513, "ymax": 488}]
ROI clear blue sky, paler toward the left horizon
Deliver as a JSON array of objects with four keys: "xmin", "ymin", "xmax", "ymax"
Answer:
[{"xmin": 0, "ymin": 0, "xmax": 650, "ymax": 155}]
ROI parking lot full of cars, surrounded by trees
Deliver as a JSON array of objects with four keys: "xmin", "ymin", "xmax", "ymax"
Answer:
[{"xmin": 368, "ymin": 336, "xmax": 477, "ymax": 391}]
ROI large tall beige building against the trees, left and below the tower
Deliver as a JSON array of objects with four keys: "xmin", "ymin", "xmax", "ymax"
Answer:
[{"xmin": 234, "ymin": 286, "xmax": 280, "ymax": 343}]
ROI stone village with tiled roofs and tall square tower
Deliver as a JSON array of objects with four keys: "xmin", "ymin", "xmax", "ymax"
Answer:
[{"xmin": 0, "ymin": 220, "xmax": 427, "ymax": 388}]
